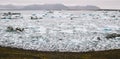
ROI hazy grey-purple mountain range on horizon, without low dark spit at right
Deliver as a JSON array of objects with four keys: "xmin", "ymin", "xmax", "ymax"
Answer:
[{"xmin": 0, "ymin": 4, "xmax": 100, "ymax": 10}]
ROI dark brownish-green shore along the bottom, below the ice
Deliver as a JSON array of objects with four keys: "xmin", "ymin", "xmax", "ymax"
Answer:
[{"xmin": 0, "ymin": 46, "xmax": 120, "ymax": 59}]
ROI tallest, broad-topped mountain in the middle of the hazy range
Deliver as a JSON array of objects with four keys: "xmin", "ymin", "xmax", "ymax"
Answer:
[{"xmin": 23, "ymin": 4, "xmax": 68, "ymax": 10}]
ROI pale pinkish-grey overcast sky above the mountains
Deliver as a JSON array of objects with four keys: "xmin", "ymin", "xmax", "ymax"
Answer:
[{"xmin": 0, "ymin": 0, "xmax": 120, "ymax": 9}]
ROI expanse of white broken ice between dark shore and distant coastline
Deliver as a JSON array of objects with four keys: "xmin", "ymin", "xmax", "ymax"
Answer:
[{"xmin": 0, "ymin": 11, "xmax": 120, "ymax": 52}]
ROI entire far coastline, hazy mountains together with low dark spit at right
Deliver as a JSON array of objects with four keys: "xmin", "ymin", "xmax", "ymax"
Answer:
[{"xmin": 0, "ymin": 4, "xmax": 120, "ymax": 11}]
